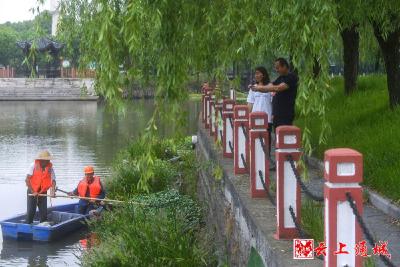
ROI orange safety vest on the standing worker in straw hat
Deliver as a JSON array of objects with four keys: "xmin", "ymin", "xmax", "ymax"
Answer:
[{"xmin": 30, "ymin": 160, "xmax": 53, "ymax": 193}]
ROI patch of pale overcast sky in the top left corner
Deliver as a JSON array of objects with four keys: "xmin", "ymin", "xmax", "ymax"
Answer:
[{"xmin": 0, "ymin": 0, "xmax": 50, "ymax": 24}]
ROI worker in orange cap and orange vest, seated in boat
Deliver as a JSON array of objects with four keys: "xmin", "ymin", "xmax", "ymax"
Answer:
[{"xmin": 68, "ymin": 166, "xmax": 106, "ymax": 214}]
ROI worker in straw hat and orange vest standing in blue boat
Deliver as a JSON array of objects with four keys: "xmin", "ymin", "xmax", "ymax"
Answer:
[{"xmin": 25, "ymin": 150, "xmax": 56, "ymax": 224}]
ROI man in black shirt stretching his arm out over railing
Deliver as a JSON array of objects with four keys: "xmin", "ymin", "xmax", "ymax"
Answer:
[{"xmin": 252, "ymin": 58, "xmax": 298, "ymax": 128}]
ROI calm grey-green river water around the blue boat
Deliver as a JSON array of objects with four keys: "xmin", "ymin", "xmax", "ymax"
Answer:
[{"xmin": 0, "ymin": 100, "xmax": 199, "ymax": 266}]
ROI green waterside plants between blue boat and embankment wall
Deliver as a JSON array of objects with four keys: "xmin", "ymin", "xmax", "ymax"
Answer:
[{"xmin": 82, "ymin": 138, "xmax": 215, "ymax": 266}]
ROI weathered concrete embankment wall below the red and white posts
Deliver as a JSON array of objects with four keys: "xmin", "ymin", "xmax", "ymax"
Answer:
[{"xmin": 197, "ymin": 120, "xmax": 323, "ymax": 267}]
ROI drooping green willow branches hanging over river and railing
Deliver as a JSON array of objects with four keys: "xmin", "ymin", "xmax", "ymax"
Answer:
[{"xmin": 54, "ymin": 0, "xmax": 338, "ymax": 193}]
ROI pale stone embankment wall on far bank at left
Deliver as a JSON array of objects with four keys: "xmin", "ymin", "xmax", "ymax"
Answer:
[{"xmin": 0, "ymin": 78, "xmax": 98, "ymax": 101}]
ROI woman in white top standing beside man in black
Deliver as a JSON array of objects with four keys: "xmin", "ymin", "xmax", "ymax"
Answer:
[{"xmin": 247, "ymin": 66, "xmax": 272, "ymax": 161}]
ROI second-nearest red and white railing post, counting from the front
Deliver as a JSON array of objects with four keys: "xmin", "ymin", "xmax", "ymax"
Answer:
[{"xmin": 275, "ymin": 126, "xmax": 301, "ymax": 239}]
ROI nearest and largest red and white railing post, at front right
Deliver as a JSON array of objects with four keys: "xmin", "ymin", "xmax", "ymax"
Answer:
[{"xmin": 324, "ymin": 148, "xmax": 363, "ymax": 267}]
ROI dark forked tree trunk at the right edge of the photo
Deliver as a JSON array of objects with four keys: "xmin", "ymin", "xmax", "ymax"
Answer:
[{"xmin": 373, "ymin": 23, "xmax": 400, "ymax": 109}]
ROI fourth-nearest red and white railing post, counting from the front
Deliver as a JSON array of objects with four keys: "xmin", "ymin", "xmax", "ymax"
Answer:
[{"xmin": 233, "ymin": 105, "xmax": 250, "ymax": 174}]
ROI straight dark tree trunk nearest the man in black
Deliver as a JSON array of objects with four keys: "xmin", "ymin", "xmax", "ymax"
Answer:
[{"xmin": 340, "ymin": 25, "xmax": 360, "ymax": 95}]
